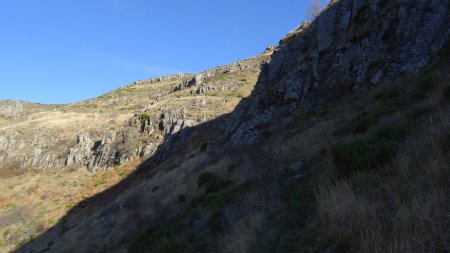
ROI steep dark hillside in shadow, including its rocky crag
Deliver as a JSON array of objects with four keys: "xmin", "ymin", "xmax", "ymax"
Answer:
[{"xmin": 7, "ymin": 0, "xmax": 450, "ymax": 253}]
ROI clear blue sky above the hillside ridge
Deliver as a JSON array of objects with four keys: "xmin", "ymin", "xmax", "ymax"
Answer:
[{"xmin": 0, "ymin": 0, "xmax": 316, "ymax": 103}]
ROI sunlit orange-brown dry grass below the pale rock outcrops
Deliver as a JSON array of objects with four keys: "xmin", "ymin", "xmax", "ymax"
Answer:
[{"xmin": 0, "ymin": 161, "xmax": 138, "ymax": 252}]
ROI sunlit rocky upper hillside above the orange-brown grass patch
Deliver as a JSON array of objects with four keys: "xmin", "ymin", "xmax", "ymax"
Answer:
[{"xmin": 0, "ymin": 52, "xmax": 270, "ymax": 172}]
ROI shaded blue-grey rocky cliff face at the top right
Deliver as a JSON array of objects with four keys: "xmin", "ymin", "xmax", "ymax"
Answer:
[{"xmin": 226, "ymin": 0, "xmax": 450, "ymax": 144}]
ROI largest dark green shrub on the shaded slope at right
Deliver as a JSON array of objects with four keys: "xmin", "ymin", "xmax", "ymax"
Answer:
[{"xmin": 330, "ymin": 126, "xmax": 406, "ymax": 176}]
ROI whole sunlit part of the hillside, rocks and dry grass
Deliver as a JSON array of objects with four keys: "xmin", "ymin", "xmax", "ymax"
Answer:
[{"xmin": 0, "ymin": 50, "xmax": 272, "ymax": 251}]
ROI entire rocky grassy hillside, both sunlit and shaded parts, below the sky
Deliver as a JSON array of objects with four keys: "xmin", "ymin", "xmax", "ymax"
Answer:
[{"xmin": 0, "ymin": 0, "xmax": 450, "ymax": 253}]
